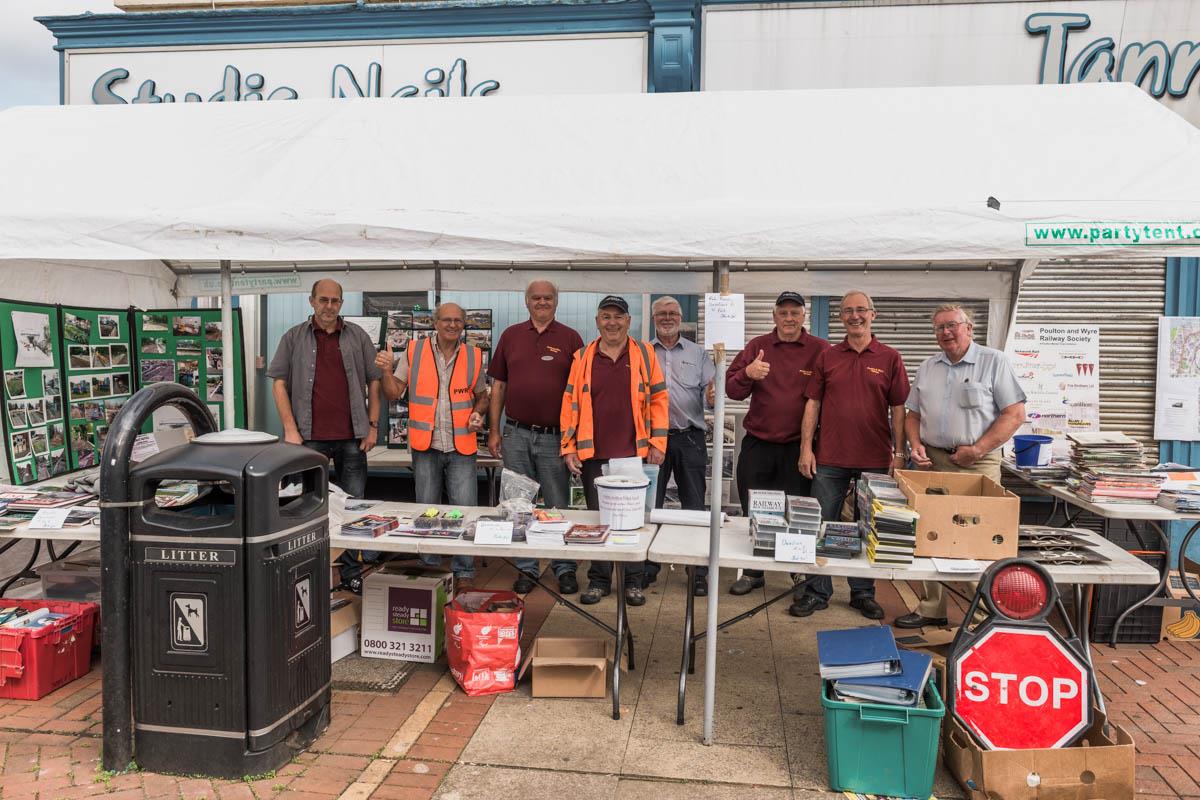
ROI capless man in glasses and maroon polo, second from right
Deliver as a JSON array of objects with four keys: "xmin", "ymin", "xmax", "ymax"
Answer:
[{"xmin": 787, "ymin": 290, "xmax": 908, "ymax": 619}]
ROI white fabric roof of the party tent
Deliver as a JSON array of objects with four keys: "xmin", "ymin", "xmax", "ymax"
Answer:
[{"xmin": 7, "ymin": 84, "xmax": 1200, "ymax": 269}]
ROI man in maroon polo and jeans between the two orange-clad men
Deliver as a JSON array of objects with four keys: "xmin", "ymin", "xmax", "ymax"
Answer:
[{"xmin": 487, "ymin": 281, "xmax": 583, "ymax": 595}]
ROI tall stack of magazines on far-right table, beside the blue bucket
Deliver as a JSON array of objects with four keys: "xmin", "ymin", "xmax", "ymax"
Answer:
[{"xmin": 1067, "ymin": 431, "xmax": 1166, "ymax": 505}]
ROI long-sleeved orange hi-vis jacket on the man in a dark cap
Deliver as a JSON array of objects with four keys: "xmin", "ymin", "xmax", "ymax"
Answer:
[{"xmin": 558, "ymin": 338, "xmax": 668, "ymax": 461}]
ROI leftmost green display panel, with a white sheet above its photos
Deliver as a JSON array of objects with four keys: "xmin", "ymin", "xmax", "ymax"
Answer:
[{"xmin": 0, "ymin": 301, "xmax": 68, "ymax": 485}]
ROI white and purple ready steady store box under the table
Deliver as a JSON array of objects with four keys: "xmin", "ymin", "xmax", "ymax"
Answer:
[{"xmin": 361, "ymin": 569, "xmax": 454, "ymax": 663}]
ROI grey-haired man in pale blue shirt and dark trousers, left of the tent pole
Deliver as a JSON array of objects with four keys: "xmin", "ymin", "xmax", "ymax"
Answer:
[{"xmin": 643, "ymin": 296, "xmax": 716, "ymax": 596}]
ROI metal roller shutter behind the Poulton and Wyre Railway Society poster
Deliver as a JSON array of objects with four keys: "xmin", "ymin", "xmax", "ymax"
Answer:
[{"xmin": 1016, "ymin": 258, "xmax": 1166, "ymax": 448}]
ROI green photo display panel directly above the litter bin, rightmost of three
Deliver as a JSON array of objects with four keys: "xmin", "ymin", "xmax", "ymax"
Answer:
[{"xmin": 132, "ymin": 308, "xmax": 246, "ymax": 428}]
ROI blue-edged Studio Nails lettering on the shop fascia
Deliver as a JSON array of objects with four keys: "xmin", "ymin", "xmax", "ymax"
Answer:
[{"xmin": 91, "ymin": 59, "xmax": 500, "ymax": 106}]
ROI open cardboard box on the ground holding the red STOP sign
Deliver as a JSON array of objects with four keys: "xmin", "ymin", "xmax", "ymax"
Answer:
[{"xmin": 943, "ymin": 709, "xmax": 1135, "ymax": 800}]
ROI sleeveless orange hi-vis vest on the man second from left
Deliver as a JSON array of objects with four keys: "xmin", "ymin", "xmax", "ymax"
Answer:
[{"xmin": 408, "ymin": 337, "xmax": 484, "ymax": 456}]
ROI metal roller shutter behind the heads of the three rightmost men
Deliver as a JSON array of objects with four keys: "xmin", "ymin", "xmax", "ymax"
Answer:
[{"xmin": 829, "ymin": 297, "xmax": 988, "ymax": 380}]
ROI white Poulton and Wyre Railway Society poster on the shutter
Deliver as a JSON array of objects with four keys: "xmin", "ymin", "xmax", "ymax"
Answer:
[{"xmin": 1006, "ymin": 325, "xmax": 1100, "ymax": 453}]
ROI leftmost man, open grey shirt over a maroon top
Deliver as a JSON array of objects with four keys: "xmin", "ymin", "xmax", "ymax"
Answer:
[{"xmin": 266, "ymin": 278, "xmax": 380, "ymax": 498}]
